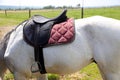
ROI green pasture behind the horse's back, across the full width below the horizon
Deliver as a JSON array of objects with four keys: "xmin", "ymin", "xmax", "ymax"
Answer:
[{"xmin": 0, "ymin": 7, "xmax": 120, "ymax": 26}]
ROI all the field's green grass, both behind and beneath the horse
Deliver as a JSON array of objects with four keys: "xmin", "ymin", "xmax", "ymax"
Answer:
[{"xmin": 0, "ymin": 7, "xmax": 120, "ymax": 80}]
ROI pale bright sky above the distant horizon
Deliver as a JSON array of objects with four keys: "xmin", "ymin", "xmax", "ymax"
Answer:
[{"xmin": 0, "ymin": 0, "xmax": 120, "ymax": 7}]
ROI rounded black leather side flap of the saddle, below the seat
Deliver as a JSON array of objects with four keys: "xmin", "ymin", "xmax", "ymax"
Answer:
[{"xmin": 23, "ymin": 20, "xmax": 53, "ymax": 46}]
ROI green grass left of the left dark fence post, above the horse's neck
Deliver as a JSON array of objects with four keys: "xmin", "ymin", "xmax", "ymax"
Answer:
[{"xmin": 0, "ymin": 11, "xmax": 28, "ymax": 26}]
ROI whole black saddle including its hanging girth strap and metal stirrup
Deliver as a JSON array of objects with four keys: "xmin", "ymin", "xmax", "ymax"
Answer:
[{"xmin": 23, "ymin": 10, "xmax": 67, "ymax": 74}]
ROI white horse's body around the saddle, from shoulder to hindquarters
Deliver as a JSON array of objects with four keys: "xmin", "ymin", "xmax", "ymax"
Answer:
[{"xmin": 0, "ymin": 16, "xmax": 120, "ymax": 80}]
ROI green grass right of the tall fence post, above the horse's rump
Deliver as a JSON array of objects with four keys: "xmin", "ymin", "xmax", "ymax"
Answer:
[{"xmin": 85, "ymin": 7, "xmax": 120, "ymax": 19}]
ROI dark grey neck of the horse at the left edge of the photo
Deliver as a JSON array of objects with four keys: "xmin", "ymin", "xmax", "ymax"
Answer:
[{"xmin": 0, "ymin": 30, "xmax": 13, "ymax": 80}]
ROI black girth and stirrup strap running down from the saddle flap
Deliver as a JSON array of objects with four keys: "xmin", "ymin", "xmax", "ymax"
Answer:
[{"xmin": 34, "ymin": 24, "xmax": 47, "ymax": 74}]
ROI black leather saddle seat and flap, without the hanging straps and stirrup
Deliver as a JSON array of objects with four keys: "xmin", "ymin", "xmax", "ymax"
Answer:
[{"xmin": 23, "ymin": 10, "xmax": 67, "ymax": 46}]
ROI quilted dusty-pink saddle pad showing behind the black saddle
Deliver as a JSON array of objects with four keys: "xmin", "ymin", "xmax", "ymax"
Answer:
[{"xmin": 48, "ymin": 18, "xmax": 75, "ymax": 44}]
